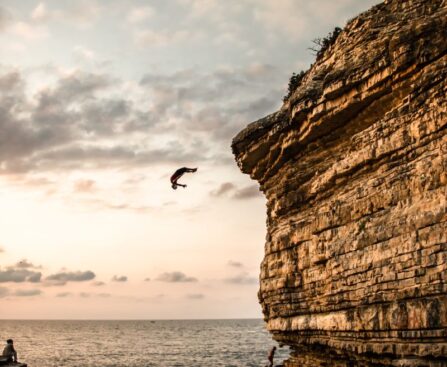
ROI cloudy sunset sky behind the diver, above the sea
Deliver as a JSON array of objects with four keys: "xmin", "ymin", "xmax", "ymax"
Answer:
[{"xmin": 0, "ymin": 0, "xmax": 379, "ymax": 319}]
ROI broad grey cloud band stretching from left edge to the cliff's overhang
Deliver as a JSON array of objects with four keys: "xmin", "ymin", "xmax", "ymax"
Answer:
[{"xmin": 0, "ymin": 64, "xmax": 283, "ymax": 183}]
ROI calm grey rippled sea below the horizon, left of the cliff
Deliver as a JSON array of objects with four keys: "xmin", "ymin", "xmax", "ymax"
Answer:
[{"xmin": 0, "ymin": 319, "xmax": 289, "ymax": 367}]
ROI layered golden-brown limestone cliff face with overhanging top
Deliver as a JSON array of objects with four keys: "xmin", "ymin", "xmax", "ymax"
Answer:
[{"xmin": 233, "ymin": 0, "xmax": 447, "ymax": 364}]
